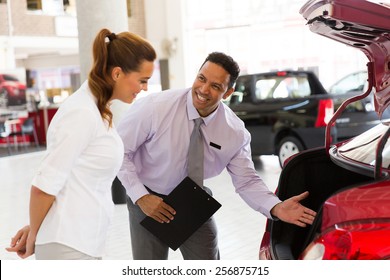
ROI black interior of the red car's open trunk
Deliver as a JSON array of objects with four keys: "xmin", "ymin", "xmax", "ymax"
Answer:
[{"xmin": 268, "ymin": 148, "xmax": 374, "ymax": 260}]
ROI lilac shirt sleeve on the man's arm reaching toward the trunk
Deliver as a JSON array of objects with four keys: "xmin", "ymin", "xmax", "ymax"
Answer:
[{"xmin": 227, "ymin": 131, "xmax": 281, "ymax": 219}]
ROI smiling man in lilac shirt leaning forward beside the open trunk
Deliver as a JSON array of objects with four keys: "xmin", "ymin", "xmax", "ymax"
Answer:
[{"xmin": 118, "ymin": 52, "xmax": 316, "ymax": 260}]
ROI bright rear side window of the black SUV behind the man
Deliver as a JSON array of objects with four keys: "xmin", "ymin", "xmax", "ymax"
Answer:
[{"xmin": 255, "ymin": 76, "xmax": 310, "ymax": 100}]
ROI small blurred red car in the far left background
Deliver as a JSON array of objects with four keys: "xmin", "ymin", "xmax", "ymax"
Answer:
[{"xmin": 0, "ymin": 74, "xmax": 26, "ymax": 107}]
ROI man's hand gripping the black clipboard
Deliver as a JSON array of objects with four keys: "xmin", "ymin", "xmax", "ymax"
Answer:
[{"xmin": 136, "ymin": 194, "xmax": 176, "ymax": 223}]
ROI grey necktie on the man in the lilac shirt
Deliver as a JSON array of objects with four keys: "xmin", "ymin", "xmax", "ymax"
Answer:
[{"xmin": 188, "ymin": 118, "xmax": 203, "ymax": 187}]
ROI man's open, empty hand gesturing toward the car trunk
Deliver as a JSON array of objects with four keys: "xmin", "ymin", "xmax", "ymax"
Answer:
[{"xmin": 271, "ymin": 191, "xmax": 317, "ymax": 227}]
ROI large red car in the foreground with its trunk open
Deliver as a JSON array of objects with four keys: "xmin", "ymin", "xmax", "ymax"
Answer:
[{"xmin": 259, "ymin": 0, "xmax": 390, "ymax": 260}]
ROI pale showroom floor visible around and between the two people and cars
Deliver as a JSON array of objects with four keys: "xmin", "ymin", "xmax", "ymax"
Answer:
[{"xmin": 0, "ymin": 151, "xmax": 280, "ymax": 260}]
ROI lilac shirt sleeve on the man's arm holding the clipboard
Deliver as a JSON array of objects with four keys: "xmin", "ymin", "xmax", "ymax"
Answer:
[{"xmin": 117, "ymin": 97, "xmax": 153, "ymax": 203}]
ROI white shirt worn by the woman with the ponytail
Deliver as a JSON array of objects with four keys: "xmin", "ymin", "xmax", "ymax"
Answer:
[{"xmin": 32, "ymin": 82, "xmax": 123, "ymax": 257}]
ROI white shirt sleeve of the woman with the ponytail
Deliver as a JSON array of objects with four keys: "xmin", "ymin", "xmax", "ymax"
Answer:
[{"xmin": 32, "ymin": 108, "xmax": 97, "ymax": 195}]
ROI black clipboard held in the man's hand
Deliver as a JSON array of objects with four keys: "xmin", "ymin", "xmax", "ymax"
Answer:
[{"xmin": 140, "ymin": 177, "xmax": 222, "ymax": 251}]
